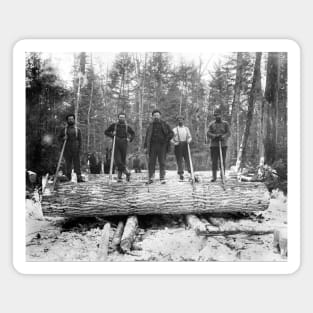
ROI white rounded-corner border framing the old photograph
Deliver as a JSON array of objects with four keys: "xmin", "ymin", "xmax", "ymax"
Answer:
[{"xmin": 12, "ymin": 39, "xmax": 301, "ymax": 274}]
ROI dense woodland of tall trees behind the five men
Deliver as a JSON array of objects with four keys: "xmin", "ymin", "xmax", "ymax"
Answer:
[{"xmin": 26, "ymin": 52, "xmax": 287, "ymax": 178}]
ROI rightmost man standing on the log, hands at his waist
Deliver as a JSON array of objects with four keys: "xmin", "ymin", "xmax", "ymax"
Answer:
[{"xmin": 207, "ymin": 109, "xmax": 230, "ymax": 182}]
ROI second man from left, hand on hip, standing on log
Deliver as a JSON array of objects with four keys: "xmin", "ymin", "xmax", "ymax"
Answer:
[{"xmin": 104, "ymin": 113, "xmax": 135, "ymax": 182}]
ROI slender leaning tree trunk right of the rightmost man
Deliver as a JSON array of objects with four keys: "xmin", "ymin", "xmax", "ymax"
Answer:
[{"xmin": 236, "ymin": 52, "xmax": 262, "ymax": 171}]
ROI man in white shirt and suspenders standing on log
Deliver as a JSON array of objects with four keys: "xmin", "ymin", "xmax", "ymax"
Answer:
[{"xmin": 171, "ymin": 115, "xmax": 192, "ymax": 180}]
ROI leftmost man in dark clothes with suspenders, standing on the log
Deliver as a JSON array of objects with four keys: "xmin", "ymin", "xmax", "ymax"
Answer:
[{"xmin": 59, "ymin": 114, "xmax": 84, "ymax": 183}]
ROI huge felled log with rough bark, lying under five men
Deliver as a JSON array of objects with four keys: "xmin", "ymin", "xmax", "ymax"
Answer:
[{"xmin": 42, "ymin": 174, "xmax": 270, "ymax": 216}]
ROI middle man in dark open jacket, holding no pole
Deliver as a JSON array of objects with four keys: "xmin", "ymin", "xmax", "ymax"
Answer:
[{"xmin": 144, "ymin": 110, "xmax": 174, "ymax": 184}]
